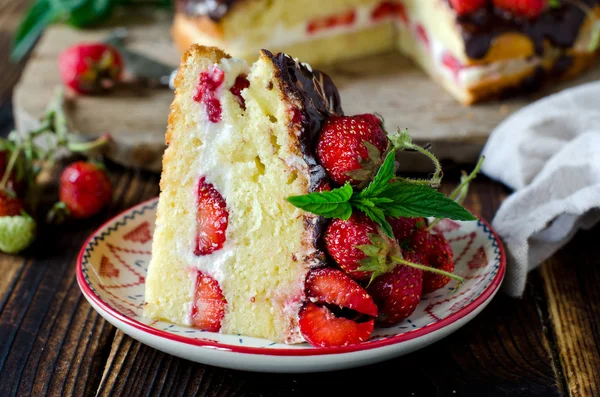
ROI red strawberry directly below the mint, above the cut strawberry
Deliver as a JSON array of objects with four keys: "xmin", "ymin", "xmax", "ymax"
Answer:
[{"xmin": 325, "ymin": 213, "xmax": 377, "ymax": 280}]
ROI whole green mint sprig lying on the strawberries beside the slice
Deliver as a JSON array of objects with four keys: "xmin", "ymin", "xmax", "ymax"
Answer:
[{"xmin": 287, "ymin": 150, "xmax": 477, "ymax": 238}]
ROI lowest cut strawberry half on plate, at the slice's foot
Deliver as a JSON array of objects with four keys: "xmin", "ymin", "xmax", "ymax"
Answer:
[{"xmin": 298, "ymin": 302, "xmax": 375, "ymax": 347}]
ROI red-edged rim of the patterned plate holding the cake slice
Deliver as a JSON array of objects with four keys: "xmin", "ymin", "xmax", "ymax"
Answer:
[{"xmin": 76, "ymin": 197, "xmax": 506, "ymax": 356}]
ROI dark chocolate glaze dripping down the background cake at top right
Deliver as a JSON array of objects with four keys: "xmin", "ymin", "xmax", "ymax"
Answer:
[{"xmin": 457, "ymin": 0, "xmax": 598, "ymax": 59}]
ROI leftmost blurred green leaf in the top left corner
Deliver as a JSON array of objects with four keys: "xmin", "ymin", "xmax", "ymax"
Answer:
[{"xmin": 10, "ymin": 0, "xmax": 61, "ymax": 62}]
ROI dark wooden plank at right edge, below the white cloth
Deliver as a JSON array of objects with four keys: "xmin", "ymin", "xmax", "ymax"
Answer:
[{"xmin": 541, "ymin": 226, "xmax": 600, "ymax": 397}]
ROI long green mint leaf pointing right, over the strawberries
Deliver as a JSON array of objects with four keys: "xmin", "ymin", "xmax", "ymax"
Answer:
[{"xmin": 380, "ymin": 182, "xmax": 477, "ymax": 221}]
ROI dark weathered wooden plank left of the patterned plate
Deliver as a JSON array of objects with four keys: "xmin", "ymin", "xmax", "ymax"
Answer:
[{"xmin": 0, "ymin": 159, "xmax": 158, "ymax": 396}]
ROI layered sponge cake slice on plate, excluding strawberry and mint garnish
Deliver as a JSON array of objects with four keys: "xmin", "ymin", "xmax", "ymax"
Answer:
[{"xmin": 145, "ymin": 42, "xmax": 342, "ymax": 343}]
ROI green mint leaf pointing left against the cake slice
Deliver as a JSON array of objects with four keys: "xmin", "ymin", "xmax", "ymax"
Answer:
[{"xmin": 287, "ymin": 183, "xmax": 354, "ymax": 220}]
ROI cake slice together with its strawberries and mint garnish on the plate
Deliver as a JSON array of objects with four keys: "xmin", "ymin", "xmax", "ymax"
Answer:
[{"xmin": 145, "ymin": 45, "xmax": 475, "ymax": 346}]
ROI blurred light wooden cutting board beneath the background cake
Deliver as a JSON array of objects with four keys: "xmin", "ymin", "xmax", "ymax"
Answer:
[{"xmin": 14, "ymin": 11, "xmax": 600, "ymax": 171}]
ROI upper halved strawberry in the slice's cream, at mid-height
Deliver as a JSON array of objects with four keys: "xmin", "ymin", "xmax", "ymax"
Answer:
[{"xmin": 195, "ymin": 177, "xmax": 229, "ymax": 256}]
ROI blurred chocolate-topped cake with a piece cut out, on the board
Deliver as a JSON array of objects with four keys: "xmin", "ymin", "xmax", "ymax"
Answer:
[{"xmin": 173, "ymin": 0, "xmax": 600, "ymax": 104}]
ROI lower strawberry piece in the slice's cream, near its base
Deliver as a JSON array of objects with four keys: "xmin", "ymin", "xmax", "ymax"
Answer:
[{"xmin": 191, "ymin": 272, "xmax": 227, "ymax": 332}]
